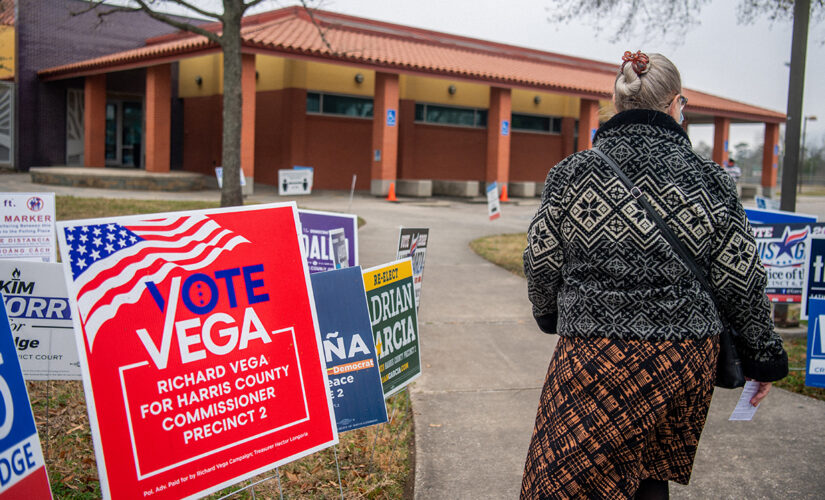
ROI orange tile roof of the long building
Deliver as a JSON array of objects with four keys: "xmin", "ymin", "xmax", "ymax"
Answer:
[{"xmin": 38, "ymin": 7, "xmax": 785, "ymax": 122}]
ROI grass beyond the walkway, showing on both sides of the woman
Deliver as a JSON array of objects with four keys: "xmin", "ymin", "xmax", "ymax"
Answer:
[{"xmin": 470, "ymin": 233, "xmax": 825, "ymax": 401}]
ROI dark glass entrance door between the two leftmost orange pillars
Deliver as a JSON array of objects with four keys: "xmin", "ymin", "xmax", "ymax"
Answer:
[{"xmin": 106, "ymin": 100, "xmax": 143, "ymax": 167}]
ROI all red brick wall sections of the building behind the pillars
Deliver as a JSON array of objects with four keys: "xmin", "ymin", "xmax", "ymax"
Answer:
[{"xmin": 183, "ymin": 89, "xmax": 564, "ymax": 190}]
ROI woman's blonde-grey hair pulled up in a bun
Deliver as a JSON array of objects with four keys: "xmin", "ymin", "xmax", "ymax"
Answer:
[{"xmin": 613, "ymin": 54, "xmax": 682, "ymax": 112}]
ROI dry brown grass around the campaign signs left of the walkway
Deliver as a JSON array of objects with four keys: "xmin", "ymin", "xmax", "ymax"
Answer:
[{"xmin": 33, "ymin": 196, "xmax": 414, "ymax": 499}]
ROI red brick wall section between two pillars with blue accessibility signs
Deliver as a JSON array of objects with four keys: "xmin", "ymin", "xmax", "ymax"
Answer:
[{"xmin": 408, "ymin": 123, "xmax": 487, "ymax": 181}]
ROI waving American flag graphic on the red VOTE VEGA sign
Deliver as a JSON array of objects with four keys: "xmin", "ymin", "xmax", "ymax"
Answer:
[{"xmin": 64, "ymin": 215, "xmax": 249, "ymax": 350}]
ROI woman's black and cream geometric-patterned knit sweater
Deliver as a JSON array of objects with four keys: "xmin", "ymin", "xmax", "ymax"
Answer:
[{"xmin": 524, "ymin": 110, "xmax": 788, "ymax": 382}]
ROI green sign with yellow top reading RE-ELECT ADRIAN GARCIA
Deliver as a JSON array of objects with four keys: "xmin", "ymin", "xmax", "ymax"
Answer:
[{"xmin": 364, "ymin": 258, "xmax": 421, "ymax": 398}]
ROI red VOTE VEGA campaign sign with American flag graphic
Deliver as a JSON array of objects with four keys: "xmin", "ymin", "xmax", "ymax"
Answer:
[{"xmin": 58, "ymin": 203, "xmax": 338, "ymax": 498}]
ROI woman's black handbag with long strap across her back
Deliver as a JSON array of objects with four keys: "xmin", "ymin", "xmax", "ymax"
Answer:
[{"xmin": 593, "ymin": 147, "xmax": 745, "ymax": 389}]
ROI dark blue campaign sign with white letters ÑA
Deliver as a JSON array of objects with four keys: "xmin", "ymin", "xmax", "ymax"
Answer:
[{"xmin": 310, "ymin": 266, "xmax": 387, "ymax": 433}]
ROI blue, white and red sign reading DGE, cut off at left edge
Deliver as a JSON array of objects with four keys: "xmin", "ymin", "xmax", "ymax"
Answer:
[{"xmin": 0, "ymin": 296, "xmax": 51, "ymax": 498}]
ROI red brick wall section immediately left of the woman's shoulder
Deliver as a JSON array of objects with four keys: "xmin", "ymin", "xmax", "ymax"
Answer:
[{"xmin": 510, "ymin": 132, "xmax": 564, "ymax": 184}]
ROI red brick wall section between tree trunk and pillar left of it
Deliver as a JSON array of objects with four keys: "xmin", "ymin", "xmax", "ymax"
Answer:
[{"xmin": 183, "ymin": 95, "xmax": 223, "ymax": 176}]
